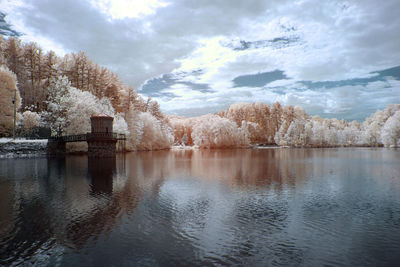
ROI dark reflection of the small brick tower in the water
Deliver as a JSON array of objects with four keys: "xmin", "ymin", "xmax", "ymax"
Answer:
[{"xmin": 88, "ymin": 157, "xmax": 116, "ymax": 194}]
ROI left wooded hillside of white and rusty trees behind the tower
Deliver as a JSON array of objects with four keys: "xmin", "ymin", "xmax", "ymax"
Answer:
[{"xmin": 0, "ymin": 36, "xmax": 173, "ymax": 150}]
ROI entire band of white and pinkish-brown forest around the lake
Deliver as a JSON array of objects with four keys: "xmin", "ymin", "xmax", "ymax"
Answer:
[{"xmin": 0, "ymin": 36, "xmax": 400, "ymax": 151}]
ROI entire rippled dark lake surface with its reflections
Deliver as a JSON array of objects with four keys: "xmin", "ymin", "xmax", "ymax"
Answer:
[{"xmin": 0, "ymin": 148, "xmax": 400, "ymax": 266}]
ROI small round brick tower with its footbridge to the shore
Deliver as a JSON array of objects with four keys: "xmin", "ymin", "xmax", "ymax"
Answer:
[{"xmin": 48, "ymin": 114, "xmax": 126, "ymax": 157}]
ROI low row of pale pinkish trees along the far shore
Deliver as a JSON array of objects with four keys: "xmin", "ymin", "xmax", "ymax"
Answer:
[{"xmin": 169, "ymin": 102, "xmax": 400, "ymax": 148}]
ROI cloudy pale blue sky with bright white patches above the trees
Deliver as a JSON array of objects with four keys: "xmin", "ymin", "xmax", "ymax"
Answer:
[{"xmin": 0, "ymin": 0, "xmax": 400, "ymax": 120}]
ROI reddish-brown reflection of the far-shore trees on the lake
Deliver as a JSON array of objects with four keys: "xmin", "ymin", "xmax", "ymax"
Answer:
[{"xmin": 143, "ymin": 149, "xmax": 312, "ymax": 191}]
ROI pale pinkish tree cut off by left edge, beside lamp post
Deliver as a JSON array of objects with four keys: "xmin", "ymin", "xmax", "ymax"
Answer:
[{"xmin": 0, "ymin": 66, "xmax": 21, "ymax": 136}]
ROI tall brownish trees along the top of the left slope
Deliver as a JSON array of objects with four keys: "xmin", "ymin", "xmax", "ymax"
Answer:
[{"xmin": 0, "ymin": 36, "xmax": 162, "ymax": 115}]
